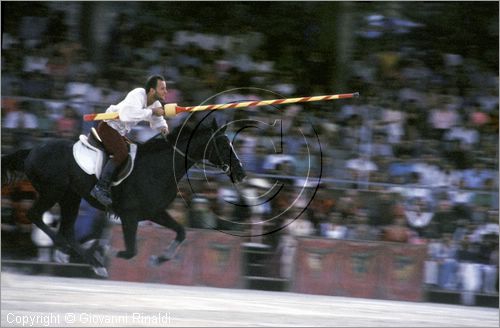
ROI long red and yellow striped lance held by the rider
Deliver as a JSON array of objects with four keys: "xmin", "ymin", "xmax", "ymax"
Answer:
[{"xmin": 84, "ymin": 92, "xmax": 359, "ymax": 121}]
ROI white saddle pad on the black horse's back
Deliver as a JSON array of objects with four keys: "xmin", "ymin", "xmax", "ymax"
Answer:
[{"xmin": 73, "ymin": 128, "xmax": 137, "ymax": 186}]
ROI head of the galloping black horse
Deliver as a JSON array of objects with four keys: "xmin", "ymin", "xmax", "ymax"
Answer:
[{"xmin": 199, "ymin": 120, "xmax": 246, "ymax": 183}]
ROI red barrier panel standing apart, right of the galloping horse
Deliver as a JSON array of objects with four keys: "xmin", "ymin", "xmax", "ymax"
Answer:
[{"xmin": 291, "ymin": 238, "xmax": 426, "ymax": 301}]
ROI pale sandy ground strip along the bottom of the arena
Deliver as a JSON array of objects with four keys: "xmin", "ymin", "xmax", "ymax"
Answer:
[{"xmin": 1, "ymin": 272, "xmax": 499, "ymax": 327}]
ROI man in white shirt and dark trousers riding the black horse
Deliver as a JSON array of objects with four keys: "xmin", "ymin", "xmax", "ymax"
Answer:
[{"xmin": 90, "ymin": 75, "xmax": 168, "ymax": 207}]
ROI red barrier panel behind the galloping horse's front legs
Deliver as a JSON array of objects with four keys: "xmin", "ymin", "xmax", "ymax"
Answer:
[{"xmin": 108, "ymin": 225, "xmax": 241, "ymax": 288}]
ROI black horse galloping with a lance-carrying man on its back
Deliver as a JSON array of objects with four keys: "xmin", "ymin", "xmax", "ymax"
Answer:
[{"xmin": 2, "ymin": 116, "xmax": 245, "ymax": 276}]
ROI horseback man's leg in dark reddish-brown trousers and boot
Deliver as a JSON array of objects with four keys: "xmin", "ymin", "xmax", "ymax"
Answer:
[{"xmin": 90, "ymin": 122, "xmax": 128, "ymax": 207}]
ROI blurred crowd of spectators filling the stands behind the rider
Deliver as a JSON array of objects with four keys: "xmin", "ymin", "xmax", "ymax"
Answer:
[{"xmin": 2, "ymin": 2, "xmax": 499, "ymax": 293}]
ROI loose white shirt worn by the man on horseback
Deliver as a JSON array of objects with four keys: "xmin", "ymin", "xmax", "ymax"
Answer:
[{"xmin": 105, "ymin": 88, "xmax": 168, "ymax": 136}]
